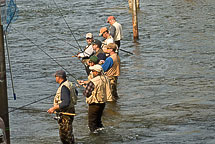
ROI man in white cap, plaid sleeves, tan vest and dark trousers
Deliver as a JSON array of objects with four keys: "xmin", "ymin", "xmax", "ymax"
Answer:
[{"xmin": 83, "ymin": 64, "xmax": 108, "ymax": 133}]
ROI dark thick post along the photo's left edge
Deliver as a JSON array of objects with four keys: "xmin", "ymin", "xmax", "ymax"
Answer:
[{"xmin": 0, "ymin": 9, "xmax": 10, "ymax": 144}]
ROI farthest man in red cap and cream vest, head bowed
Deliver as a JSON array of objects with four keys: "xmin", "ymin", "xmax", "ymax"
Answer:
[{"xmin": 107, "ymin": 16, "xmax": 123, "ymax": 48}]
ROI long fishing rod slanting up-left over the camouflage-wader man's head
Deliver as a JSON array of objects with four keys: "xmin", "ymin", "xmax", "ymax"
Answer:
[{"xmin": 13, "ymin": 27, "xmax": 78, "ymax": 81}]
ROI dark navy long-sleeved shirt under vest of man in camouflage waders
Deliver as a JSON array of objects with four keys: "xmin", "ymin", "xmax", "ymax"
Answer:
[{"xmin": 59, "ymin": 81, "xmax": 70, "ymax": 109}]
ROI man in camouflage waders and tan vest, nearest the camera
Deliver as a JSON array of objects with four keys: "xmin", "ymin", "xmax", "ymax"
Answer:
[{"xmin": 47, "ymin": 70, "xmax": 77, "ymax": 144}]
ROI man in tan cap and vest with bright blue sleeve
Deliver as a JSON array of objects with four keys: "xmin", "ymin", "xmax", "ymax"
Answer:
[{"xmin": 102, "ymin": 43, "xmax": 120, "ymax": 100}]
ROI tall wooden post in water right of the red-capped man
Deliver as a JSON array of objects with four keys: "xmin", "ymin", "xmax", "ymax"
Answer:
[{"xmin": 132, "ymin": 0, "xmax": 139, "ymax": 41}]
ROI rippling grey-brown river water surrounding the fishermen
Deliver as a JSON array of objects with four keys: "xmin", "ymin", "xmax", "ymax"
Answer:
[{"xmin": 4, "ymin": 0, "xmax": 215, "ymax": 144}]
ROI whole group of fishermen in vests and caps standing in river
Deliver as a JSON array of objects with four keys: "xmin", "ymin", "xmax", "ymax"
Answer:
[{"xmin": 47, "ymin": 16, "xmax": 122, "ymax": 144}]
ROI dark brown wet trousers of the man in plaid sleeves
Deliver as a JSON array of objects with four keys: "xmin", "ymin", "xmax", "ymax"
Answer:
[{"xmin": 88, "ymin": 103, "xmax": 105, "ymax": 132}]
